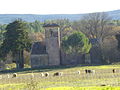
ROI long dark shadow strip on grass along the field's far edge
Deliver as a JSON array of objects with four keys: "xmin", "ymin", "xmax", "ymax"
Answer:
[{"xmin": 0, "ymin": 64, "xmax": 107, "ymax": 74}]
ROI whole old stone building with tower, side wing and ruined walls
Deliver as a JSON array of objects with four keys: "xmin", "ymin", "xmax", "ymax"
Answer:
[{"xmin": 31, "ymin": 24, "xmax": 100, "ymax": 68}]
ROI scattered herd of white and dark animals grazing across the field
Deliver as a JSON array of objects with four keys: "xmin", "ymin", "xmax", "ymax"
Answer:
[{"xmin": 0, "ymin": 69, "xmax": 116, "ymax": 79}]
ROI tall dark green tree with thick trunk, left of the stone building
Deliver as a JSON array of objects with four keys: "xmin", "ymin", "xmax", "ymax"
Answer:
[{"xmin": 1, "ymin": 19, "xmax": 31, "ymax": 69}]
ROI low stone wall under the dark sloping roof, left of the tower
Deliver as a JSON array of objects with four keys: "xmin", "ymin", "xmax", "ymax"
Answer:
[{"xmin": 31, "ymin": 54, "xmax": 48, "ymax": 68}]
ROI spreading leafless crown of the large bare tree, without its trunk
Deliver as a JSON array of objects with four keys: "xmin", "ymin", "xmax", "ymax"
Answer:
[{"xmin": 80, "ymin": 12, "xmax": 112, "ymax": 44}]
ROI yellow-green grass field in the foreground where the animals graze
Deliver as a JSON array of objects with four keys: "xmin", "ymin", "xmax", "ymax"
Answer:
[{"xmin": 0, "ymin": 65, "xmax": 120, "ymax": 90}]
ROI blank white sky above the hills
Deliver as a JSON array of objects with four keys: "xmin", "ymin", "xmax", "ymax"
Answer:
[{"xmin": 0, "ymin": 0, "xmax": 120, "ymax": 14}]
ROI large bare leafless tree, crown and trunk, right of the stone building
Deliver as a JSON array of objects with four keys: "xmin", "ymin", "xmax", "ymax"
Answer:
[{"xmin": 77, "ymin": 12, "xmax": 113, "ymax": 63}]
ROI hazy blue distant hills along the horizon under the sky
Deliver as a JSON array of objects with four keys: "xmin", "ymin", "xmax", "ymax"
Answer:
[{"xmin": 0, "ymin": 10, "xmax": 120, "ymax": 24}]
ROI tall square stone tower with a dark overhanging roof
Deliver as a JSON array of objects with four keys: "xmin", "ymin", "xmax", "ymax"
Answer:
[{"xmin": 43, "ymin": 24, "xmax": 60, "ymax": 66}]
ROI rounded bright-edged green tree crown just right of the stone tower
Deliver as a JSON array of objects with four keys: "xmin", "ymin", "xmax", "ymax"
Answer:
[{"xmin": 62, "ymin": 32, "xmax": 91, "ymax": 53}]
